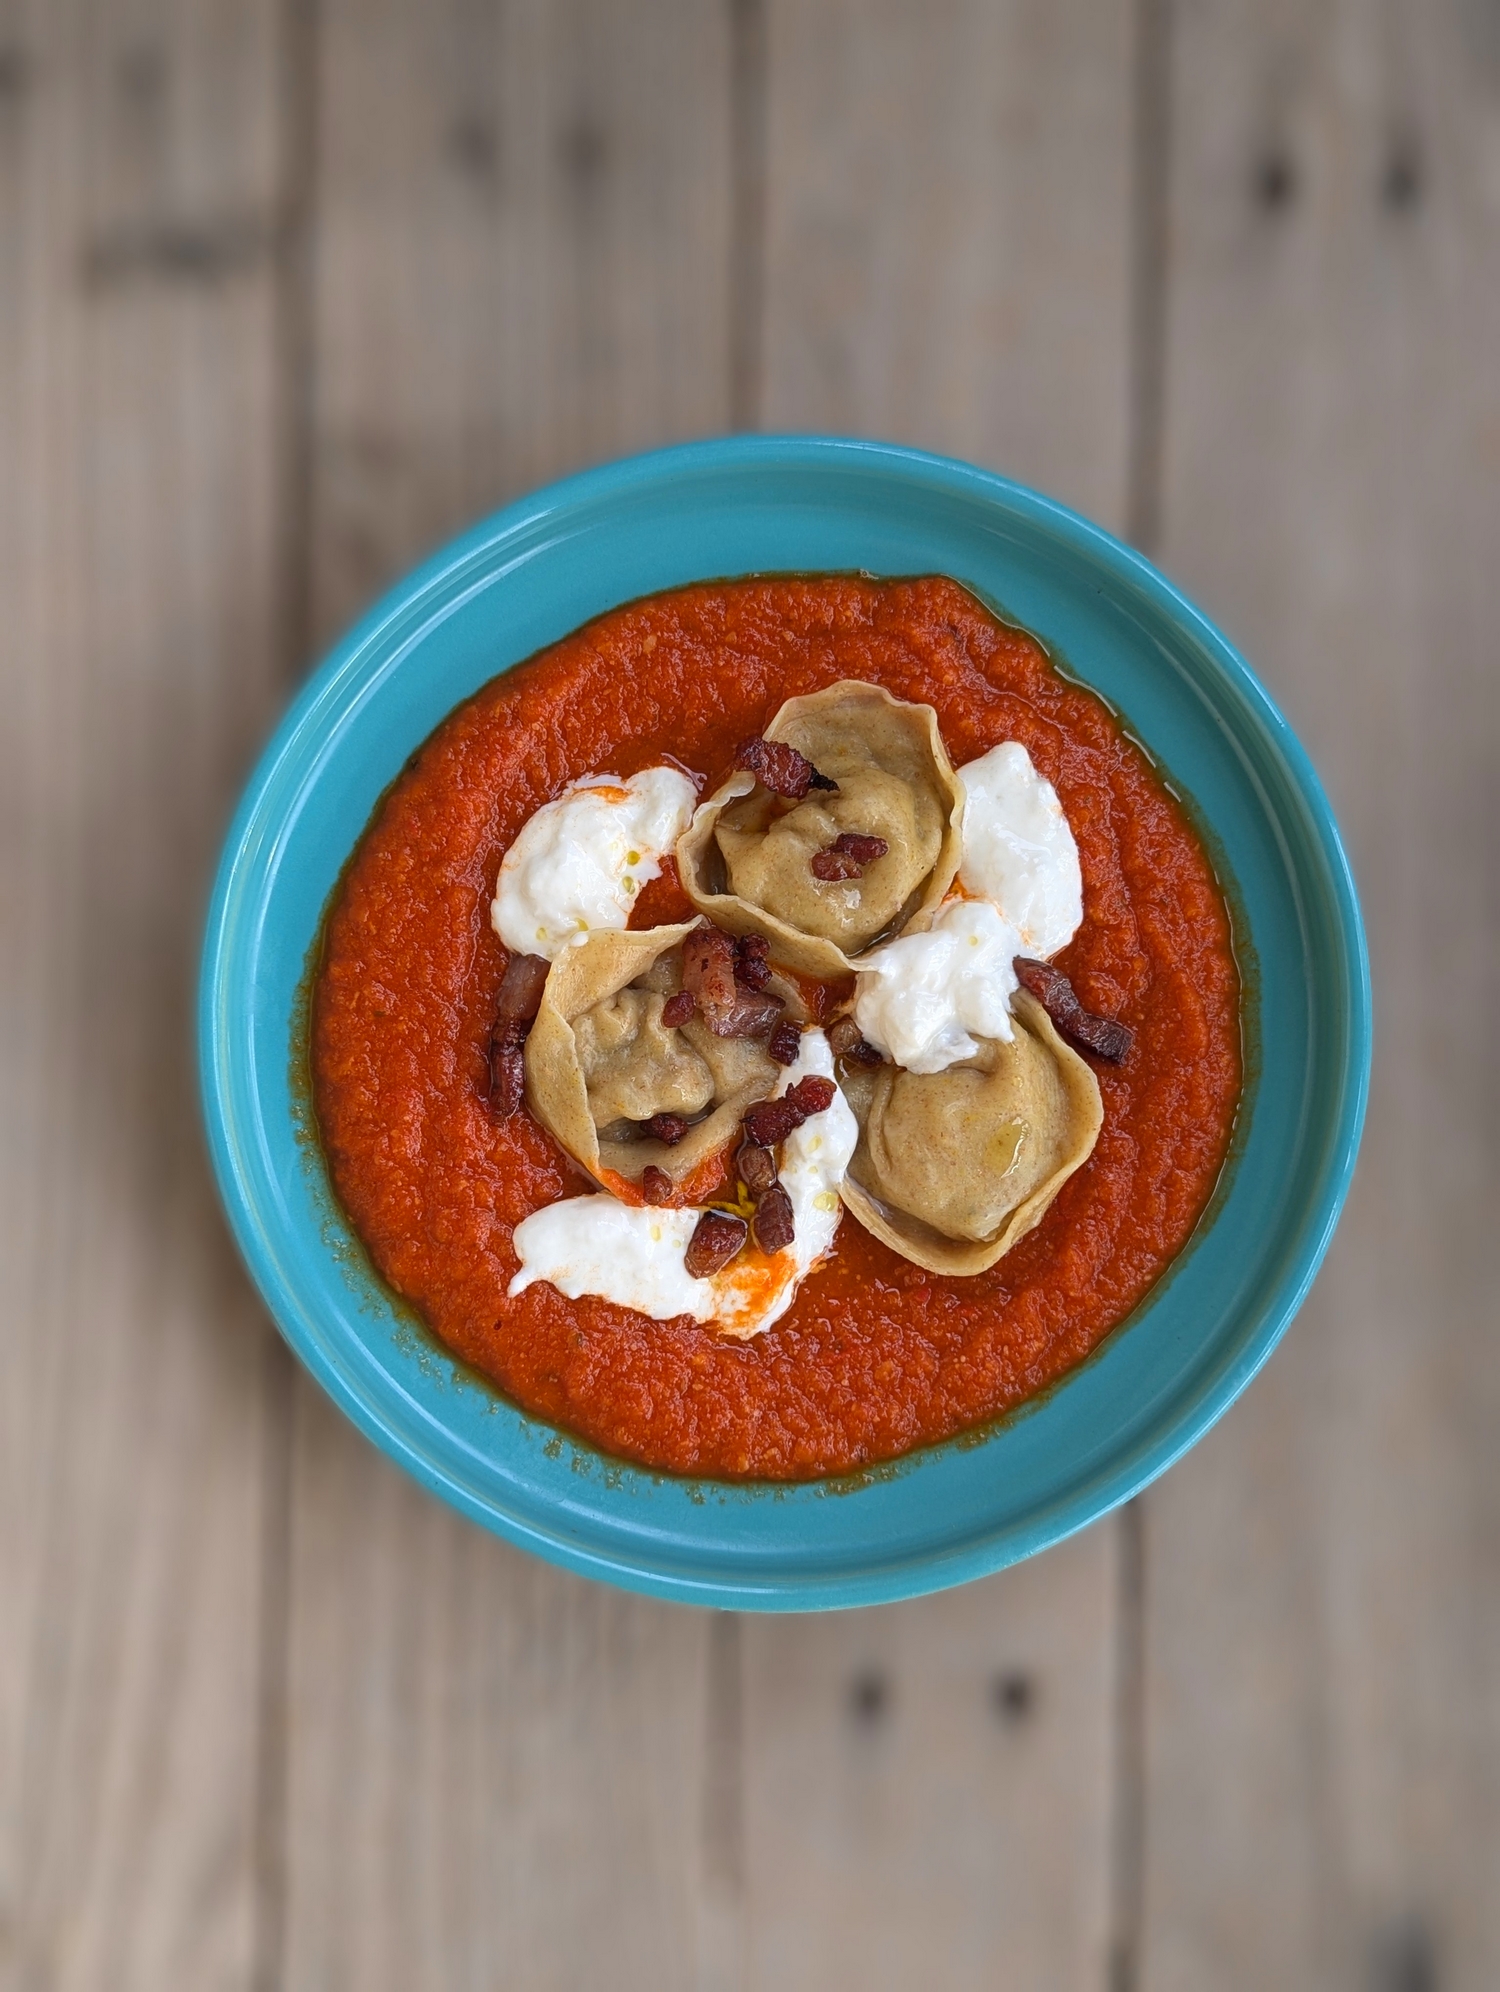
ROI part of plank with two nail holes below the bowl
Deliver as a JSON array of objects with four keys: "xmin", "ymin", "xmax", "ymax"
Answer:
[{"xmin": 743, "ymin": 1528, "xmax": 1114, "ymax": 1992}]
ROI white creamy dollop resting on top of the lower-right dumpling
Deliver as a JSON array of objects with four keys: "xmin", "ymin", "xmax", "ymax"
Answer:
[{"xmin": 855, "ymin": 898, "xmax": 1026, "ymax": 1072}]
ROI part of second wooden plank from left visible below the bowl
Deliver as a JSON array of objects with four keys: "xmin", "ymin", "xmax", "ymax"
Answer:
[{"xmin": 285, "ymin": 1388, "xmax": 725, "ymax": 1992}]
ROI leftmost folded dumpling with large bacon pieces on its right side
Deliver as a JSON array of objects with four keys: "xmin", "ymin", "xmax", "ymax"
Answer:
[{"xmin": 526, "ymin": 920, "xmax": 801, "ymax": 1193}]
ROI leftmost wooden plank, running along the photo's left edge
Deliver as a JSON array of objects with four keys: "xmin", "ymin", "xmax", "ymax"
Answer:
[{"xmin": 0, "ymin": 0, "xmax": 281, "ymax": 1992}]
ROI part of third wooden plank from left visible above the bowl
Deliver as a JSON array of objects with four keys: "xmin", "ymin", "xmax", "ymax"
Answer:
[{"xmin": 763, "ymin": 0, "xmax": 1131, "ymax": 522}]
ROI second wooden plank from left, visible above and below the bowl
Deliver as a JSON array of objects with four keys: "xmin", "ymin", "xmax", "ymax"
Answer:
[{"xmin": 285, "ymin": 0, "xmax": 731, "ymax": 1992}]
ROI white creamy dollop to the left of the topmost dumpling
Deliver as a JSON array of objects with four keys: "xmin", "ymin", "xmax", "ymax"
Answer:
[{"xmin": 490, "ymin": 767, "xmax": 697, "ymax": 960}]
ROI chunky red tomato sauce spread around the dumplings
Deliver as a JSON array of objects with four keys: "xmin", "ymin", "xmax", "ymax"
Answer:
[{"xmin": 311, "ymin": 576, "xmax": 1241, "ymax": 1480}]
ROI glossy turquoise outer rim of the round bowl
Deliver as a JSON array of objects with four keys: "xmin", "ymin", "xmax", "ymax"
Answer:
[{"xmin": 197, "ymin": 434, "xmax": 1373, "ymax": 1612}]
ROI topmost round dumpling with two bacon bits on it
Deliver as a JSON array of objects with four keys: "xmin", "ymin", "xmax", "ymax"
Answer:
[{"xmin": 677, "ymin": 679, "xmax": 962, "ymax": 978}]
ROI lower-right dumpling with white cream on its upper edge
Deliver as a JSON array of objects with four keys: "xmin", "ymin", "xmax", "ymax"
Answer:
[{"xmin": 843, "ymin": 990, "xmax": 1104, "ymax": 1275}]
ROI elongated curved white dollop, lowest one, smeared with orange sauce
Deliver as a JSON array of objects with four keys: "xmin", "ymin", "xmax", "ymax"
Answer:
[{"xmin": 510, "ymin": 1030, "xmax": 859, "ymax": 1341}]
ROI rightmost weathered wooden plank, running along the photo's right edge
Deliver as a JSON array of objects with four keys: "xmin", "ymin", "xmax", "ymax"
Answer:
[{"xmin": 1143, "ymin": 0, "xmax": 1500, "ymax": 1992}]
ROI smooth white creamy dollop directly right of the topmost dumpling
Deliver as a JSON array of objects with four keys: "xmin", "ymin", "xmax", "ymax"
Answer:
[{"xmin": 958, "ymin": 741, "xmax": 1084, "ymax": 962}]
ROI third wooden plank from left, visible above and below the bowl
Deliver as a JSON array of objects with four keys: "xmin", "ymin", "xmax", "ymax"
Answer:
[{"xmin": 743, "ymin": 0, "xmax": 1131, "ymax": 1992}]
